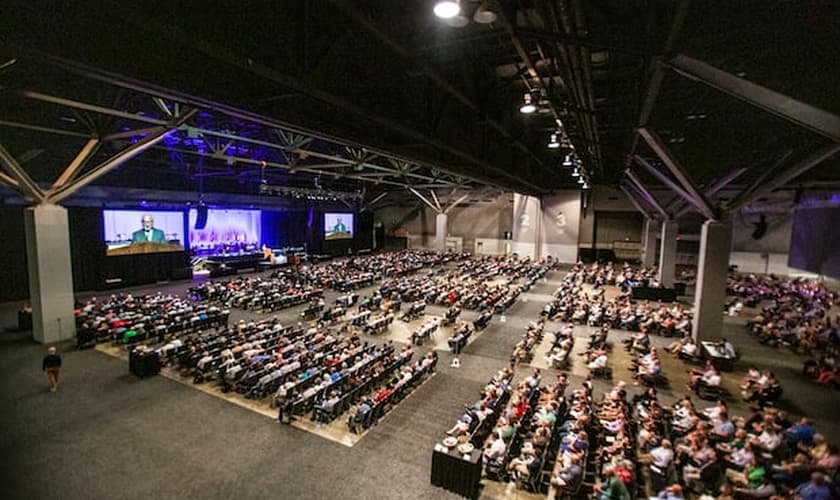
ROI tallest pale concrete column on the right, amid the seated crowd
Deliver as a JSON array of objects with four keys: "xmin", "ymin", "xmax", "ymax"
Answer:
[{"xmin": 691, "ymin": 220, "xmax": 732, "ymax": 341}]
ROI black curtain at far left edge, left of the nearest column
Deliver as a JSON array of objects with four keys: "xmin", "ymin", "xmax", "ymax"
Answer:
[{"xmin": 0, "ymin": 205, "xmax": 29, "ymax": 302}]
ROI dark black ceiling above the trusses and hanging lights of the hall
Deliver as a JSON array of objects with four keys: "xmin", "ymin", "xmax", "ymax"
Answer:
[{"xmin": 0, "ymin": 0, "xmax": 840, "ymax": 205}]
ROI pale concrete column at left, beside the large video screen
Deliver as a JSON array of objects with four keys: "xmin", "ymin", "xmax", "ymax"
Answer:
[{"xmin": 24, "ymin": 204, "xmax": 76, "ymax": 344}]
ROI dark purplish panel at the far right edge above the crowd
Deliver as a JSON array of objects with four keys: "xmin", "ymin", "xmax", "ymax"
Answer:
[{"xmin": 788, "ymin": 205, "xmax": 840, "ymax": 278}]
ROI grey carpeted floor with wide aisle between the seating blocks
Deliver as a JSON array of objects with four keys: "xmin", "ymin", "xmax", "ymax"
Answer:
[{"xmin": 0, "ymin": 272, "xmax": 840, "ymax": 499}]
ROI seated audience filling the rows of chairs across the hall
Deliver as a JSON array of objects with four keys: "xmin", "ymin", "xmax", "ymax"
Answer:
[{"xmin": 76, "ymin": 251, "xmax": 840, "ymax": 500}]
